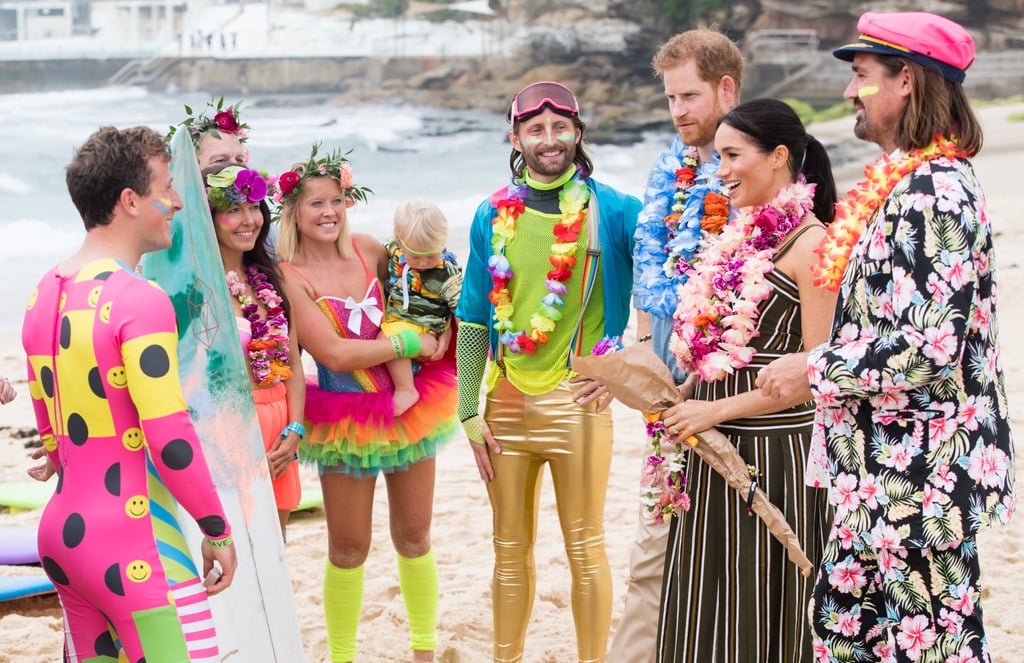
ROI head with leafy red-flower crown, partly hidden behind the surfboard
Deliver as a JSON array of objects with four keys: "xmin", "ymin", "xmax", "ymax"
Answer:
[{"xmin": 167, "ymin": 97, "xmax": 249, "ymax": 171}]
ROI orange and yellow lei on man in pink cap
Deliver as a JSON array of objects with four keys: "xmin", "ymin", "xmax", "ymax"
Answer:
[{"xmin": 811, "ymin": 134, "xmax": 967, "ymax": 292}]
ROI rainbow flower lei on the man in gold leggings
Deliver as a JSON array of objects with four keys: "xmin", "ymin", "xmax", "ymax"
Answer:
[{"xmin": 487, "ymin": 172, "xmax": 590, "ymax": 355}]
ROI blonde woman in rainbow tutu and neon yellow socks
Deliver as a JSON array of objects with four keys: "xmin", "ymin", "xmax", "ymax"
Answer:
[{"xmin": 274, "ymin": 147, "xmax": 458, "ymax": 662}]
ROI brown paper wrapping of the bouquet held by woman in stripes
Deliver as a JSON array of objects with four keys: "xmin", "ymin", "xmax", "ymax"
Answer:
[{"xmin": 572, "ymin": 343, "xmax": 813, "ymax": 576}]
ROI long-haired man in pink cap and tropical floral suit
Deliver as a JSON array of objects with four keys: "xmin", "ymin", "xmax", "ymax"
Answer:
[{"xmin": 758, "ymin": 12, "xmax": 1015, "ymax": 663}]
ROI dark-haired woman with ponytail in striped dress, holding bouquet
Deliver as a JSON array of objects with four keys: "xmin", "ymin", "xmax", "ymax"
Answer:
[{"xmin": 658, "ymin": 99, "xmax": 836, "ymax": 663}]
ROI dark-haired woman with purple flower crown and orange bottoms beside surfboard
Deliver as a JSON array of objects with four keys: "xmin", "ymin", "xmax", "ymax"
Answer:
[{"xmin": 203, "ymin": 165, "xmax": 306, "ymax": 536}]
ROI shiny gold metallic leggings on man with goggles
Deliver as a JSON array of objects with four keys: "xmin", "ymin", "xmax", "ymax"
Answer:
[{"xmin": 484, "ymin": 379, "xmax": 611, "ymax": 663}]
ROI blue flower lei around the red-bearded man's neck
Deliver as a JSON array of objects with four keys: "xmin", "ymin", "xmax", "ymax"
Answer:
[{"xmin": 633, "ymin": 135, "xmax": 722, "ymax": 319}]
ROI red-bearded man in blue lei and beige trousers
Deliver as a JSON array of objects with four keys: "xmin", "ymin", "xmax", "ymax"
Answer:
[{"xmin": 608, "ymin": 29, "xmax": 743, "ymax": 663}]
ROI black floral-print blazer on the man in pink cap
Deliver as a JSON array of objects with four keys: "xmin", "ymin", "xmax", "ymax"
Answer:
[{"xmin": 808, "ymin": 158, "xmax": 1015, "ymax": 548}]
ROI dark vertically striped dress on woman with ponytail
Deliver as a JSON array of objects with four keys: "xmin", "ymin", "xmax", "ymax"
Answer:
[{"xmin": 657, "ymin": 256, "xmax": 831, "ymax": 663}]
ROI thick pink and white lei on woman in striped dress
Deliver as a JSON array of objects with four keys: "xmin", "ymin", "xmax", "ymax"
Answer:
[{"xmin": 671, "ymin": 177, "xmax": 814, "ymax": 382}]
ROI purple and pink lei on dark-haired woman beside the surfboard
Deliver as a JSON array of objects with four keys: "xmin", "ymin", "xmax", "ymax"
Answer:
[{"xmin": 224, "ymin": 264, "xmax": 292, "ymax": 386}]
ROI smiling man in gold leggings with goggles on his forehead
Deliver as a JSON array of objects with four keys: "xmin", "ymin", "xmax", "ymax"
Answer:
[{"xmin": 456, "ymin": 81, "xmax": 641, "ymax": 663}]
